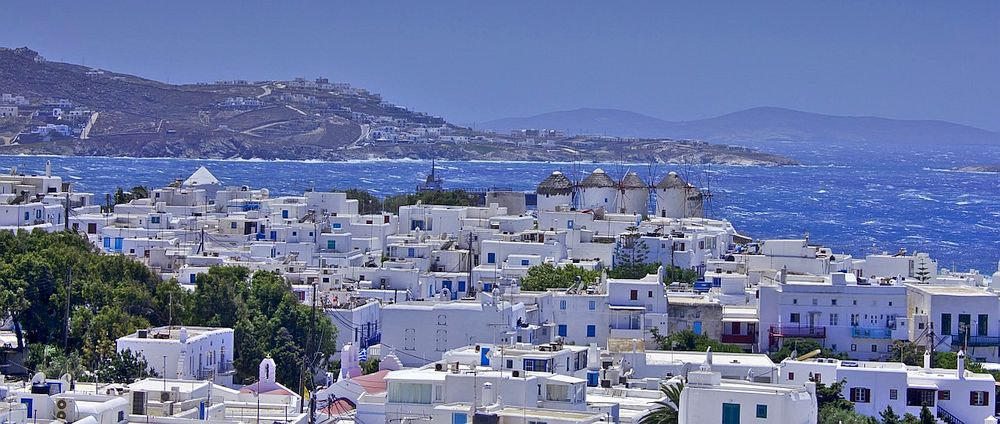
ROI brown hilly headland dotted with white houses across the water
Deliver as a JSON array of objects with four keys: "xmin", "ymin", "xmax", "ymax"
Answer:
[{"xmin": 0, "ymin": 47, "xmax": 795, "ymax": 165}]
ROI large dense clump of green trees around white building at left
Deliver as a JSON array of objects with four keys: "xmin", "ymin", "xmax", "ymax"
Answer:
[{"xmin": 0, "ymin": 230, "xmax": 336, "ymax": 387}]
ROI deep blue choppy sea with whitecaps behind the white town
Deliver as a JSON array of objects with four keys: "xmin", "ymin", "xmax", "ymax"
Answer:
[{"xmin": 0, "ymin": 143, "xmax": 1000, "ymax": 274}]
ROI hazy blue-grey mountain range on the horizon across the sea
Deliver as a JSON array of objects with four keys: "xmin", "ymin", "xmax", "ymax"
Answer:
[{"xmin": 477, "ymin": 107, "xmax": 1000, "ymax": 144}]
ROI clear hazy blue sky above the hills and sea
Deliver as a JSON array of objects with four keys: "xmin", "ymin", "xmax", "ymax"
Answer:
[{"xmin": 0, "ymin": 0, "xmax": 1000, "ymax": 130}]
